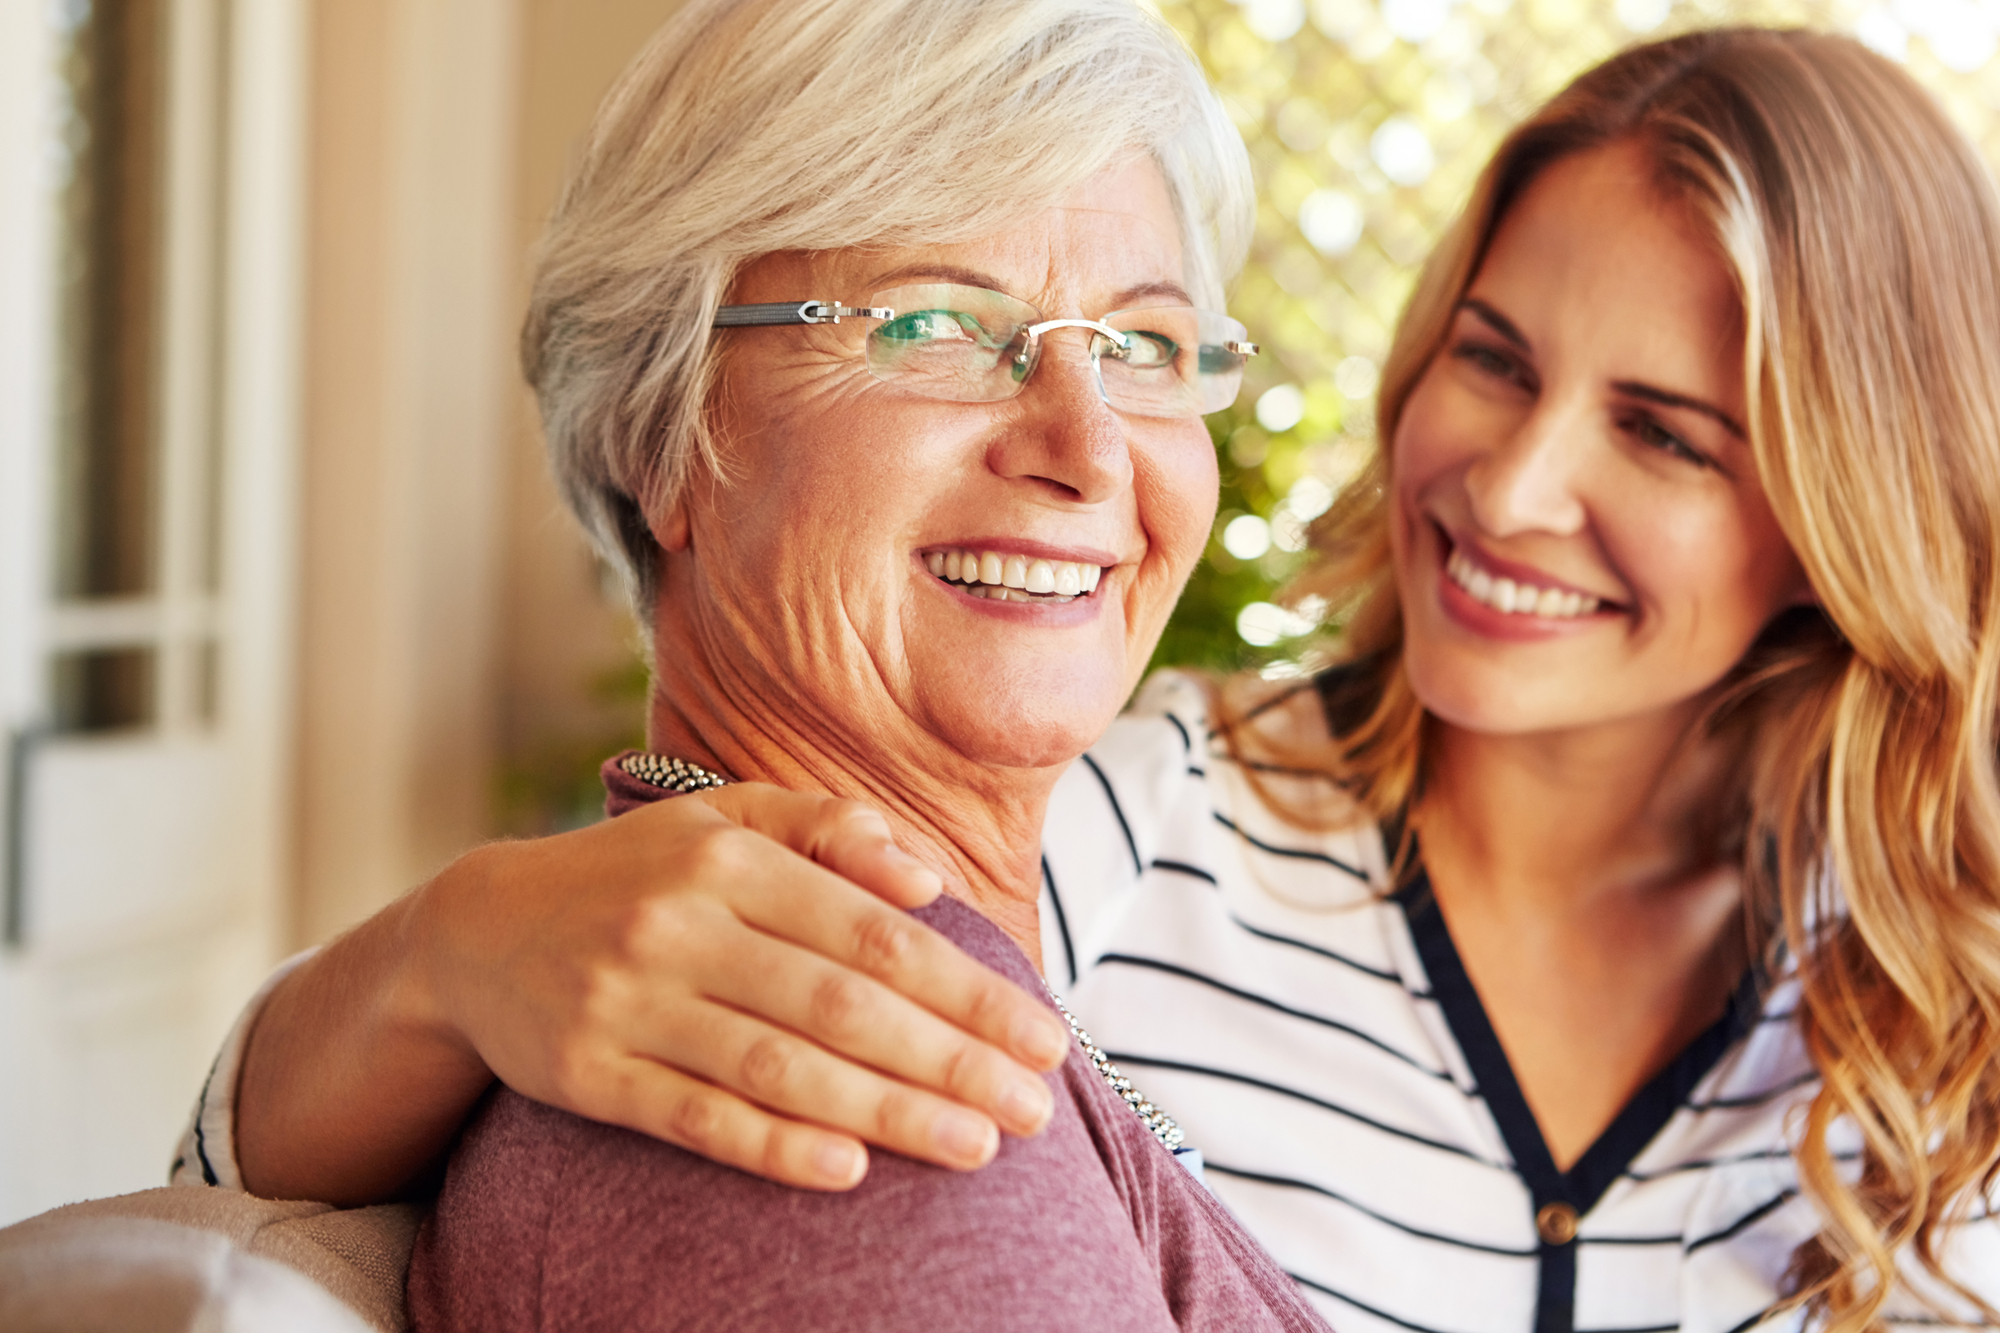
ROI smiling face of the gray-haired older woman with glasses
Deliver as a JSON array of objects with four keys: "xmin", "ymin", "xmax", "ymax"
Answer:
[{"xmin": 656, "ymin": 158, "xmax": 1216, "ymax": 791}]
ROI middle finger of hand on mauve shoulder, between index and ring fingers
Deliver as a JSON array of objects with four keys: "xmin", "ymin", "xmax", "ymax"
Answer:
[{"xmin": 684, "ymin": 931, "xmax": 1054, "ymax": 1135}]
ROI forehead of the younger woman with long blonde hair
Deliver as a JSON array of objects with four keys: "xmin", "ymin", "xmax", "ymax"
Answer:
[{"xmin": 1470, "ymin": 144, "xmax": 1742, "ymax": 392}]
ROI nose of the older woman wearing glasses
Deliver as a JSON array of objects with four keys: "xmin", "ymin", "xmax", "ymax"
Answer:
[{"xmin": 988, "ymin": 328, "xmax": 1132, "ymax": 504}]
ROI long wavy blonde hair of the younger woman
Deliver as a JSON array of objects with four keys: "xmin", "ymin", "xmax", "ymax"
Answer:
[{"xmin": 1264, "ymin": 30, "xmax": 2000, "ymax": 1333}]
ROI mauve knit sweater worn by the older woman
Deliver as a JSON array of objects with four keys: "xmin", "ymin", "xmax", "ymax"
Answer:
[{"xmin": 408, "ymin": 763, "xmax": 1326, "ymax": 1333}]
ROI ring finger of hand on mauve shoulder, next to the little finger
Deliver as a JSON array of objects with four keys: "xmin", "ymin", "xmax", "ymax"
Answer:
[{"xmin": 648, "ymin": 1005, "xmax": 1000, "ymax": 1171}]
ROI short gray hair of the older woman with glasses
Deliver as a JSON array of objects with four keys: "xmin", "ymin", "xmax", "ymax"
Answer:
[{"xmin": 522, "ymin": 0, "xmax": 1254, "ymax": 622}]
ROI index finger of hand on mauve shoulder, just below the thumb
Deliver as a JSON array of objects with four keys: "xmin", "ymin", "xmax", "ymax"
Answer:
[{"xmin": 738, "ymin": 860, "xmax": 1070, "ymax": 1069}]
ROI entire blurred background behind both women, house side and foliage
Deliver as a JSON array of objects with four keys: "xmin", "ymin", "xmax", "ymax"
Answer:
[{"xmin": 0, "ymin": 0, "xmax": 2000, "ymax": 1223}]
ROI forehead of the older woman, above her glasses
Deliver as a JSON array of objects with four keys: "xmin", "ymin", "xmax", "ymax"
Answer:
[{"xmin": 730, "ymin": 158, "xmax": 1186, "ymax": 312}]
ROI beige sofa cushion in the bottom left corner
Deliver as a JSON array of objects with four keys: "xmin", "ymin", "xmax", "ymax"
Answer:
[{"xmin": 0, "ymin": 1185, "xmax": 420, "ymax": 1333}]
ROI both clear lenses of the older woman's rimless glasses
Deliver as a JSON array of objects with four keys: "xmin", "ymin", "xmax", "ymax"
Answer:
[{"xmin": 868, "ymin": 282, "xmax": 1248, "ymax": 416}]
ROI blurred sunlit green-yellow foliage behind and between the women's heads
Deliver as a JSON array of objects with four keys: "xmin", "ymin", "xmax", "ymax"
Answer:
[{"xmin": 1154, "ymin": 0, "xmax": 2000, "ymax": 669}]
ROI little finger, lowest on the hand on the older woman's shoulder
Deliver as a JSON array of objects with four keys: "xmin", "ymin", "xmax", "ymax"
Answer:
[{"xmin": 568, "ymin": 1057, "xmax": 868, "ymax": 1191}]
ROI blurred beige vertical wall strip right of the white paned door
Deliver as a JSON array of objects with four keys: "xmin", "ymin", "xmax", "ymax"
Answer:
[{"xmin": 294, "ymin": 0, "xmax": 520, "ymax": 941}]
